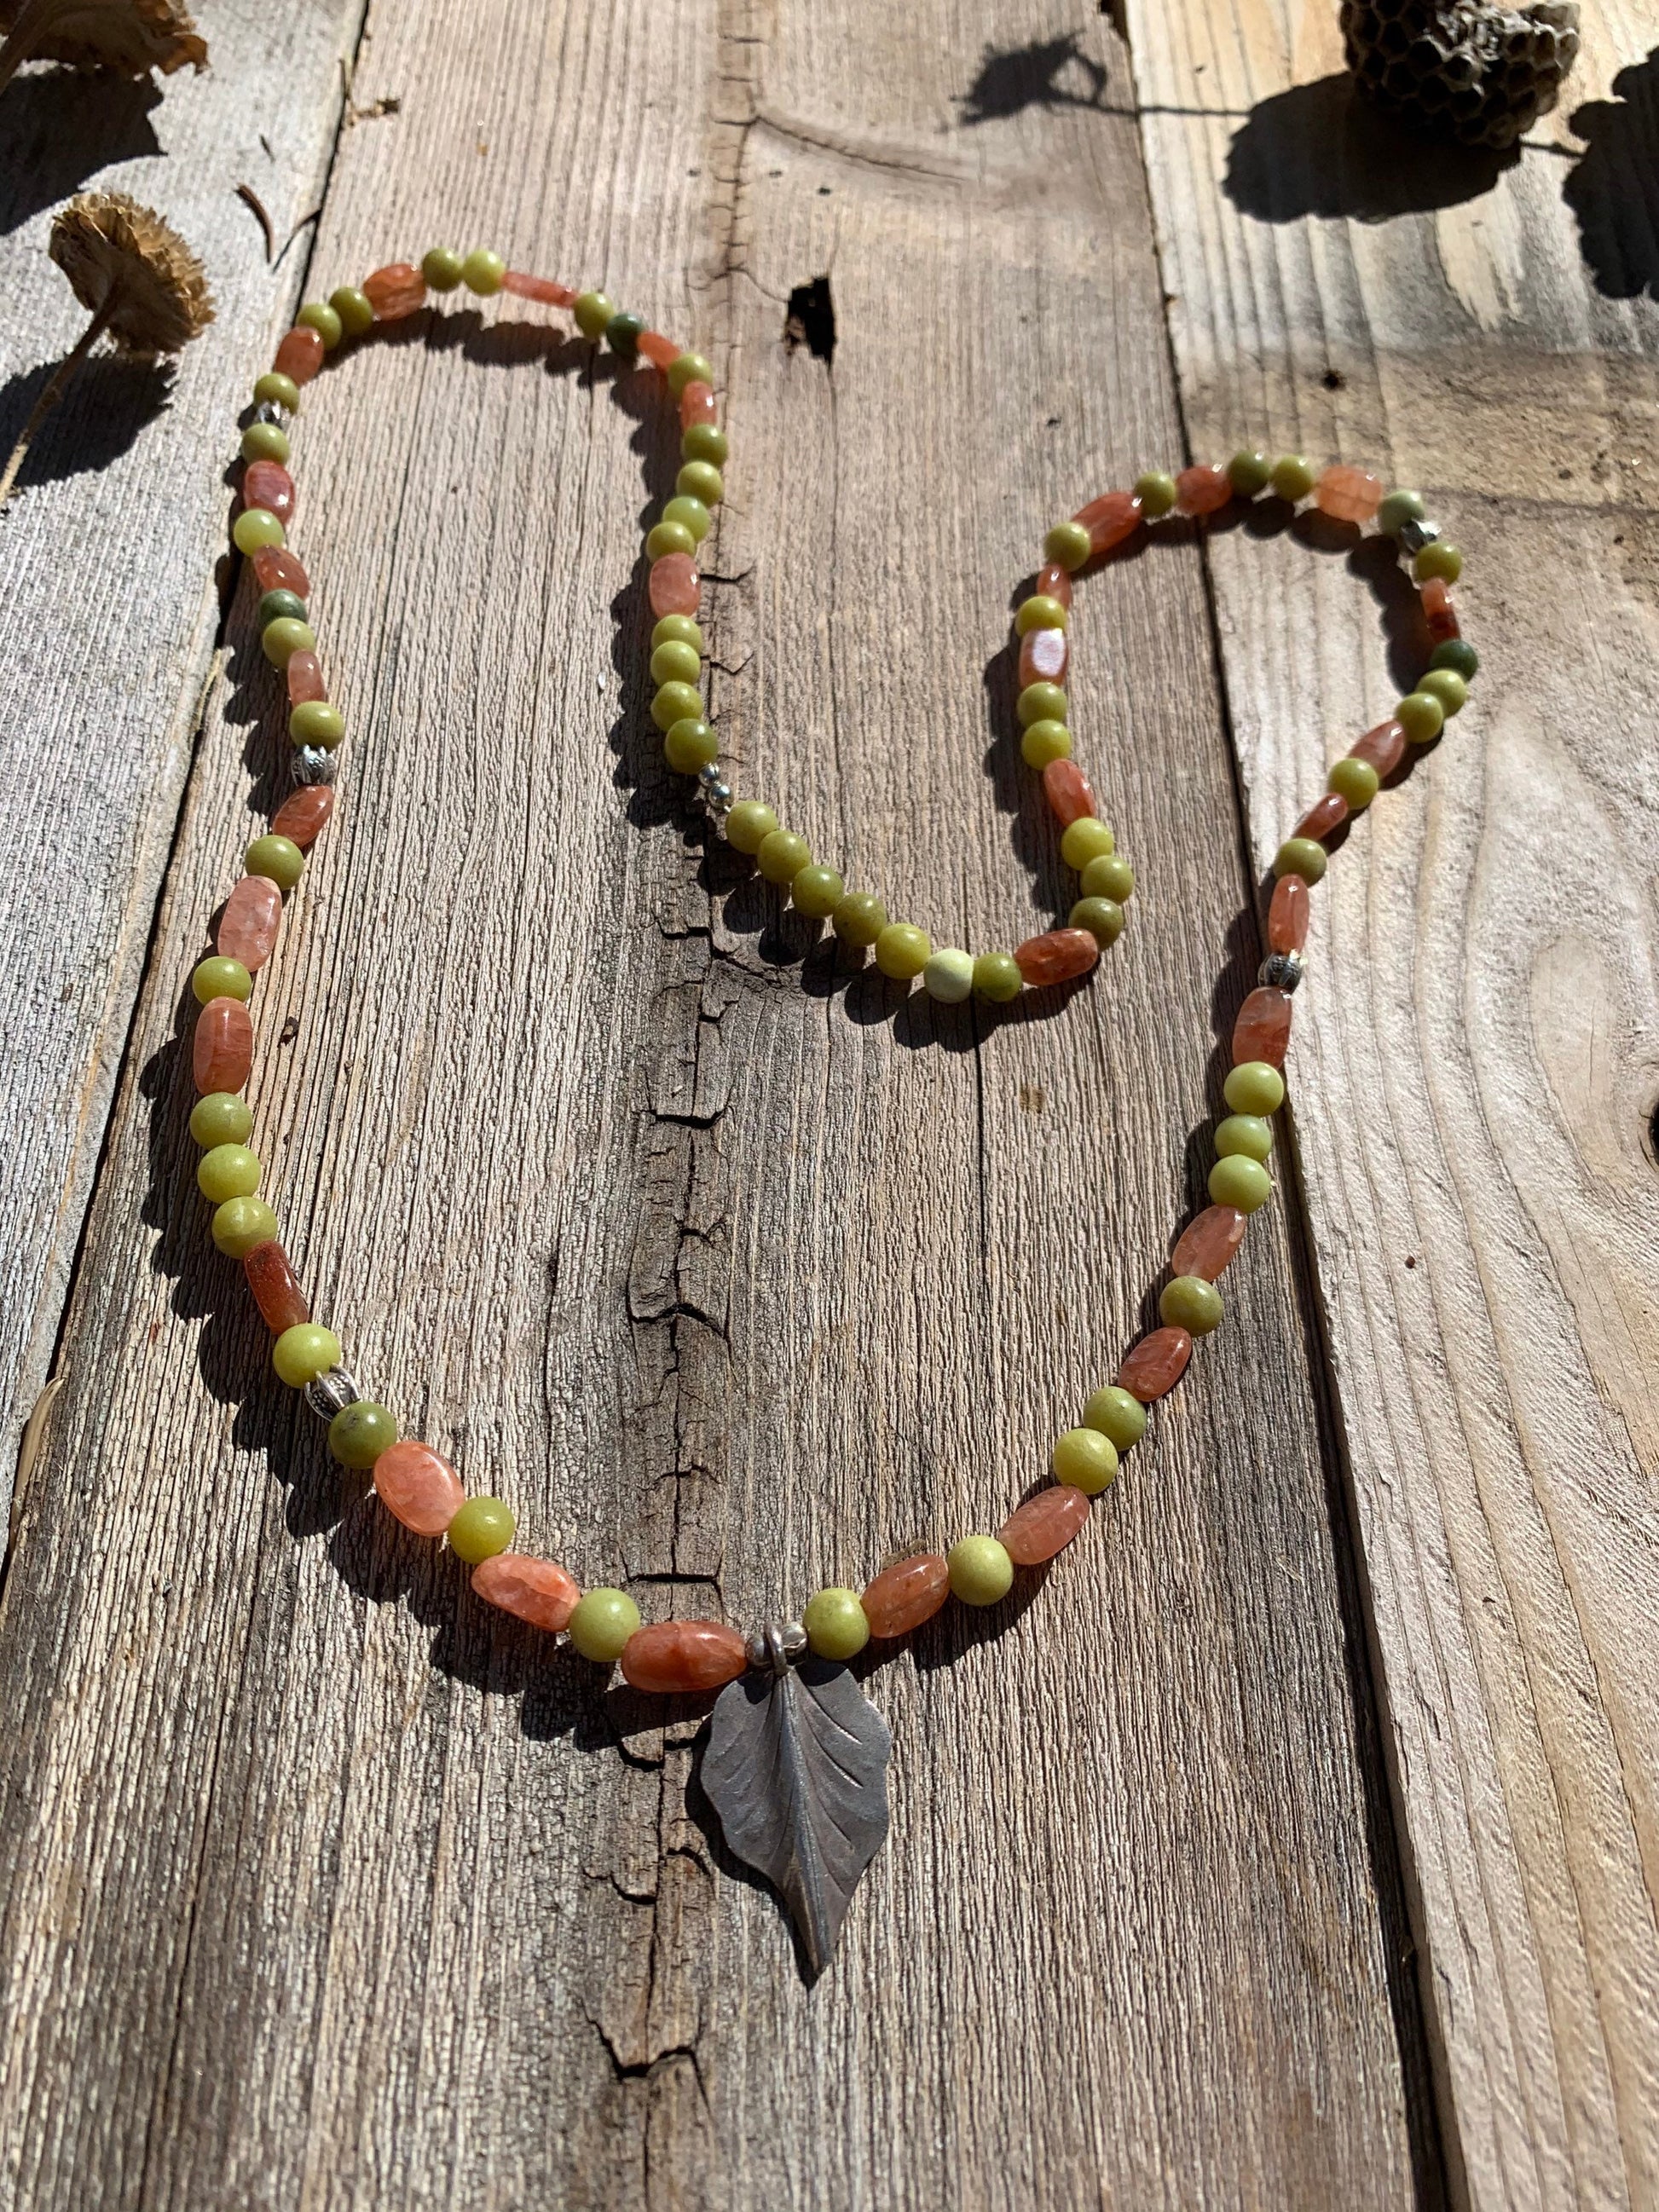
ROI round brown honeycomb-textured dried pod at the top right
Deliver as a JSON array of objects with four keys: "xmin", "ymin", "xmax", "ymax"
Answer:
[{"xmin": 1343, "ymin": 0, "xmax": 1580, "ymax": 146}]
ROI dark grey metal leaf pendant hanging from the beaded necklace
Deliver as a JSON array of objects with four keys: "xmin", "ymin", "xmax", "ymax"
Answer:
[{"xmin": 703, "ymin": 1659, "xmax": 893, "ymax": 1975}]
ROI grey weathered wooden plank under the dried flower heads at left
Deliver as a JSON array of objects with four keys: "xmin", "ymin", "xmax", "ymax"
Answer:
[{"xmin": 0, "ymin": 0, "xmax": 363, "ymax": 1510}]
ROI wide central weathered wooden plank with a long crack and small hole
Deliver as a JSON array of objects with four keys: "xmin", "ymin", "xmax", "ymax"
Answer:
[{"xmin": 0, "ymin": 0, "xmax": 1436, "ymax": 2208}]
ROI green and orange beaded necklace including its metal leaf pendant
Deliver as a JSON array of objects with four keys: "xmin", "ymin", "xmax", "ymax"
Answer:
[{"xmin": 201, "ymin": 250, "xmax": 1477, "ymax": 1973}]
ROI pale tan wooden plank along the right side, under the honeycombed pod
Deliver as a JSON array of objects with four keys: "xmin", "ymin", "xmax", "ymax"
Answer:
[{"xmin": 1130, "ymin": 0, "xmax": 1659, "ymax": 2208}]
